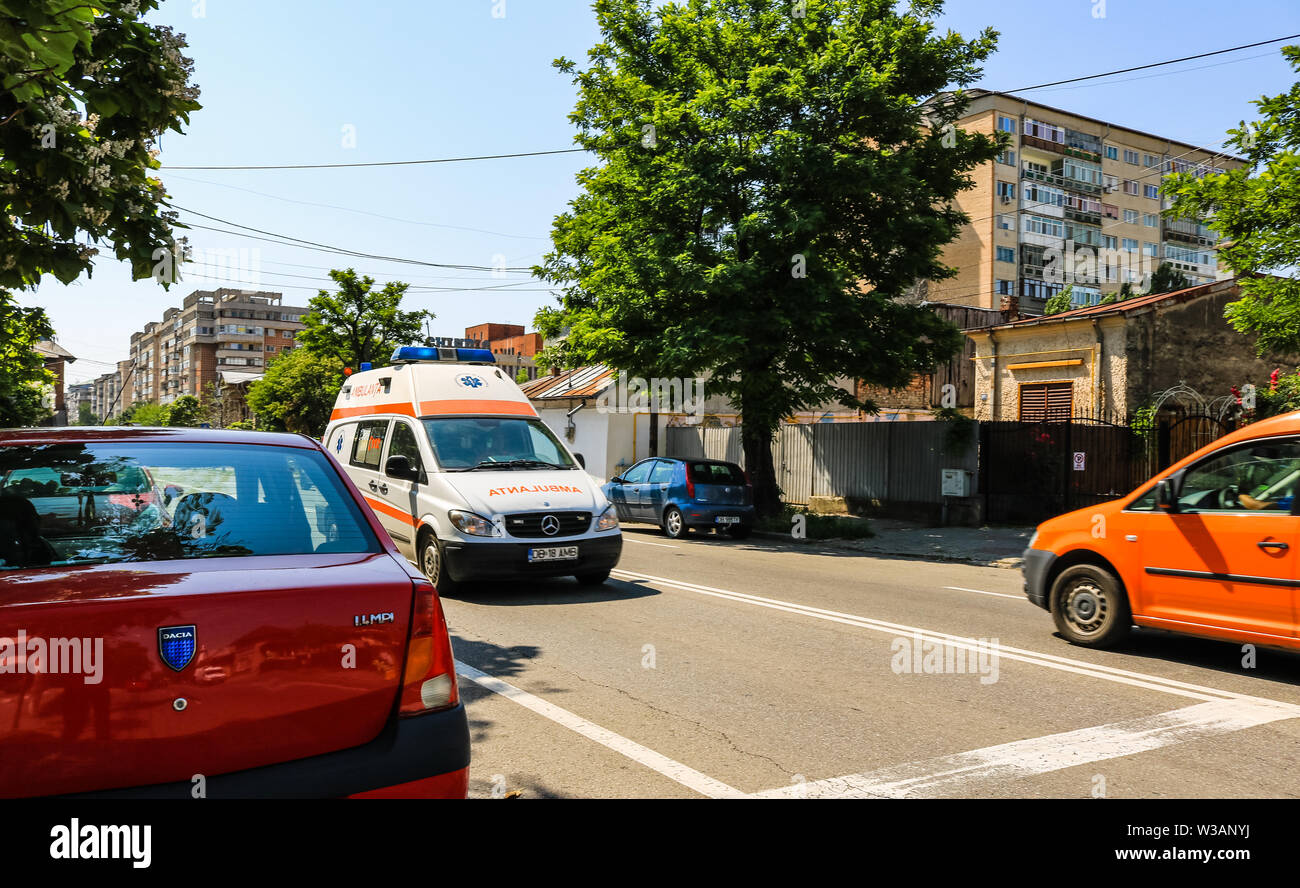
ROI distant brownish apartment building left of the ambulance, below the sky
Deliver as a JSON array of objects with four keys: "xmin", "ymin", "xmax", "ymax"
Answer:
[{"xmin": 130, "ymin": 287, "xmax": 309, "ymax": 404}]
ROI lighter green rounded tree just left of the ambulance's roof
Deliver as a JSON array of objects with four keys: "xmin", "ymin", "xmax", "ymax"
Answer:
[{"xmin": 247, "ymin": 348, "xmax": 343, "ymax": 437}]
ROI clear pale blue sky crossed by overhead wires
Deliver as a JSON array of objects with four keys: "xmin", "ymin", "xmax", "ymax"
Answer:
[{"xmin": 35, "ymin": 0, "xmax": 1300, "ymax": 381}]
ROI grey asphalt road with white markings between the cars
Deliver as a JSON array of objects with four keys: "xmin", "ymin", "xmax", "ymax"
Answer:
[{"xmin": 445, "ymin": 525, "xmax": 1300, "ymax": 798}]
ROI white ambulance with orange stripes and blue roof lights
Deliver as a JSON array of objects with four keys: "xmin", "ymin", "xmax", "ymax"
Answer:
[{"xmin": 322, "ymin": 346, "xmax": 623, "ymax": 592}]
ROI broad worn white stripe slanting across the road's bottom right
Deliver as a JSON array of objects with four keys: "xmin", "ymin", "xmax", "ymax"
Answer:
[{"xmin": 753, "ymin": 699, "xmax": 1300, "ymax": 798}]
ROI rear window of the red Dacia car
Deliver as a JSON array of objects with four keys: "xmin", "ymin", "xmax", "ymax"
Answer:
[{"xmin": 0, "ymin": 442, "xmax": 380, "ymax": 571}]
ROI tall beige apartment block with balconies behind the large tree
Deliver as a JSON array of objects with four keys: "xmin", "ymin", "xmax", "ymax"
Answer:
[{"xmin": 924, "ymin": 90, "xmax": 1244, "ymax": 316}]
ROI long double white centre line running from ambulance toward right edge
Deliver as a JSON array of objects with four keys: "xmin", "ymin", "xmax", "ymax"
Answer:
[{"xmin": 614, "ymin": 568, "xmax": 1300, "ymax": 711}]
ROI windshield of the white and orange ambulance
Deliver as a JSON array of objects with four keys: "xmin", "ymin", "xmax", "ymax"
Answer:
[{"xmin": 424, "ymin": 416, "xmax": 576, "ymax": 472}]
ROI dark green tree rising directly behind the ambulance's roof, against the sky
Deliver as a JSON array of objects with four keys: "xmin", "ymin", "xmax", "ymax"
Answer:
[{"xmin": 298, "ymin": 268, "xmax": 434, "ymax": 369}]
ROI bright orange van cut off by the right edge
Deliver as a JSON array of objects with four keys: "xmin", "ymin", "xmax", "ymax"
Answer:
[{"xmin": 1024, "ymin": 412, "xmax": 1300, "ymax": 649}]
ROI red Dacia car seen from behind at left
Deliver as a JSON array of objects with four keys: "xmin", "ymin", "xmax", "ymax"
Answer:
[{"xmin": 0, "ymin": 428, "xmax": 469, "ymax": 798}]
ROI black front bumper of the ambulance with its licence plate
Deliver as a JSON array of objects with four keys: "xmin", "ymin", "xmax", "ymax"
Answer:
[{"xmin": 443, "ymin": 532, "xmax": 623, "ymax": 582}]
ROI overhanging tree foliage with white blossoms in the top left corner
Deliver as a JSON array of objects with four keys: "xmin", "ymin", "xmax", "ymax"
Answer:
[{"xmin": 0, "ymin": 0, "xmax": 199, "ymax": 289}]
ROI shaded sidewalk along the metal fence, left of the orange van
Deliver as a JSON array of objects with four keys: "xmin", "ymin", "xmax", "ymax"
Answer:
[{"xmin": 762, "ymin": 517, "xmax": 1034, "ymax": 569}]
